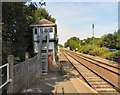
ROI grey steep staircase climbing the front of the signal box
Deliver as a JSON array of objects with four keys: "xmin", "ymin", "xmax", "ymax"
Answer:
[{"xmin": 38, "ymin": 31, "xmax": 49, "ymax": 75}]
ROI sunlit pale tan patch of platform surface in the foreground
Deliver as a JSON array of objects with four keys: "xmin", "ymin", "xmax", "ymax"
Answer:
[{"xmin": 52, "ymin": 78, "xmax": 97, "ymax": 95}]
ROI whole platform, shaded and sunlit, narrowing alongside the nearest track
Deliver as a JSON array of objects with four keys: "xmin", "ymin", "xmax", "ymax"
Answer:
[{"xmin": 22, "ymin": 51, "xmax": 97, "ymax": 95}]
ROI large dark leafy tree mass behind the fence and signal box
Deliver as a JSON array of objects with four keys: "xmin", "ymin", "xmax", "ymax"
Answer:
[{"xmin": 2, "ymin": 2, "xmax": 55, "ymax": 63}]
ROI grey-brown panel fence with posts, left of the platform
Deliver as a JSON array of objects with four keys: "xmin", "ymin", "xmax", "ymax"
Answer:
[{"xmin": 1, "ymin": 53, "xmax": 41, "ymax": 93}]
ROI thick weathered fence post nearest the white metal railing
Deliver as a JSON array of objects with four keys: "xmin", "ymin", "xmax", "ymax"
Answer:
[{"xmin": 7, "ymin": 55, "xmax": 14, "ymax": 94}]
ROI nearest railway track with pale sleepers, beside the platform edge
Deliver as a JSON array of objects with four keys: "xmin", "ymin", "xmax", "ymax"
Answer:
[{"xmin": 61, "ymin": 50, "xmax": 120, "ymax": 95}]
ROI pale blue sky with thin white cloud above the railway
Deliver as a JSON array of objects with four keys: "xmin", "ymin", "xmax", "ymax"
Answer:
[{"xmin": 33, "ymin": 0, "xmax": 118, "ymax": 45}]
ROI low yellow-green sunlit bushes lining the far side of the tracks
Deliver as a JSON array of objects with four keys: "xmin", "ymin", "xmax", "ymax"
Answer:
[{"xmin": 79, "ymin": 44, "xmax": 120, "ymax": 61}]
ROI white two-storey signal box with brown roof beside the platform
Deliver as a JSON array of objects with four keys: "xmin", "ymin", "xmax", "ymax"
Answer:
[{"xmin": 30, "ymin": 19, "xmax": 58, "ymax": 61}]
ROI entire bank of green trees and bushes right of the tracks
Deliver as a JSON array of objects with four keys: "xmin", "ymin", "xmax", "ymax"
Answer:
[{"xmin": 64, "ymin": 30, "xmax": 120, "ymax": 61}]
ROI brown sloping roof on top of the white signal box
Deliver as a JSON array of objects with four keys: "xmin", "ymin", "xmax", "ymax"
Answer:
[{"xmin": 30, "ymin": 19, "xmax": 56, "ymax": 27}]
